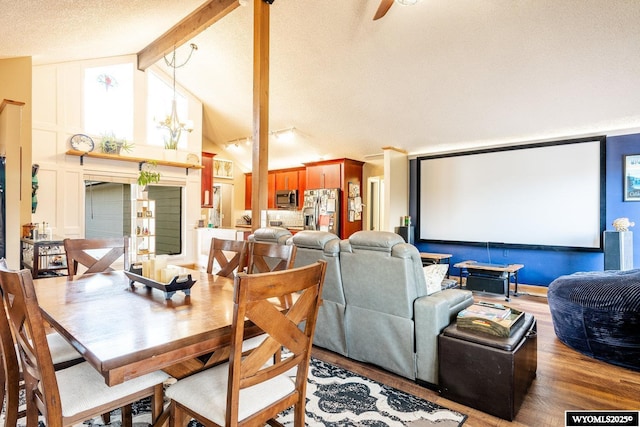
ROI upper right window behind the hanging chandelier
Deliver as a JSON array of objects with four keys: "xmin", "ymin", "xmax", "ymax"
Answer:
[{"xmin": 147, "ymin": 71, "xmax": 189, "ymax": 149}]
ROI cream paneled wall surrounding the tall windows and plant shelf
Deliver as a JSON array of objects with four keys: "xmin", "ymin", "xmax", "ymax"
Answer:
[{"xmin": 33, "ymin": 55, "xmax": 202, "ymax": 263}]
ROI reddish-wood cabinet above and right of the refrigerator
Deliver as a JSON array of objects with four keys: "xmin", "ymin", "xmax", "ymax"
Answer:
[{"xmin": 305, "ymin": 159, "xmax": 364, "ymax": 239}]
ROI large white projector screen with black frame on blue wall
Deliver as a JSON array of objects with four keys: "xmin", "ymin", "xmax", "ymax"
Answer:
[{"xmin": 416, "ymin": 137, "xmax": 605, "ymax": 250}]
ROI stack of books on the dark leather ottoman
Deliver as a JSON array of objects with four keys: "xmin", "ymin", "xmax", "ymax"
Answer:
[{"xmin": 456, "ymin": 302, "xmax": 524, "ymax": 337}]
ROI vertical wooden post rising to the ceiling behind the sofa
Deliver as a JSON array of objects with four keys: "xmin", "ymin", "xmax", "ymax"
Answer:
[{"xmin": 251, "ymin": 0, "xmax": 269, "ymax": 230}]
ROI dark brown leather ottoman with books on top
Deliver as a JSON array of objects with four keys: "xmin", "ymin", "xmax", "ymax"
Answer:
[{"xmin": 438, "ymin": 314, "xmax": 538, "ymax": 421}]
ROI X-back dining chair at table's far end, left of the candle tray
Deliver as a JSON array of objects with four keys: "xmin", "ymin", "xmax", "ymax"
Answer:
[{"xmin": 63, "ymin": 236, "xmax": 129, "ymax": 280}]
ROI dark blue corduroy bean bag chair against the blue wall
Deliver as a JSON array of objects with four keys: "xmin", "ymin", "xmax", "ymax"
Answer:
[{"xmin": 547, "ymin": 269, "xmax": 640, "ymax": 371}]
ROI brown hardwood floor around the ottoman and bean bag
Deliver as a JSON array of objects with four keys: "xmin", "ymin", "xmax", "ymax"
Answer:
[{"xmin": 313, "ymin": 294, "xmax": 640, "ymax": 427}]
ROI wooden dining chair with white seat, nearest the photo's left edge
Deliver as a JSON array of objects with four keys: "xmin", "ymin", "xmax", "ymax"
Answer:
[{"xmin": 0, "ymin": 270, "xmax": 168, "ymax": 427}]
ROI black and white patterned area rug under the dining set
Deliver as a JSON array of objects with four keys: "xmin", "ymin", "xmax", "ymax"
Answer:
[{"xmin": 0, "ymin": 358, "xmax": 467, "ymax": 427}]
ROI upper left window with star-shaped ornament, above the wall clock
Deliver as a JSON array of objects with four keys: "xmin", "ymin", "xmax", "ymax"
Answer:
[{"xmin": 84, "ymin": 63, "xmax": 133, "ymax": 141}]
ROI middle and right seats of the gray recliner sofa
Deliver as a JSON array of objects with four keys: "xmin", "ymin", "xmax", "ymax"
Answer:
[{"xmin": 287, "ymin": 231, "xmax": 473, "ymax": 384}]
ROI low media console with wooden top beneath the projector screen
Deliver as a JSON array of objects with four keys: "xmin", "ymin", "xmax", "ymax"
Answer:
[{"xmin": 454, "ymin": 261, "xmax": 524, "ymax": 301}]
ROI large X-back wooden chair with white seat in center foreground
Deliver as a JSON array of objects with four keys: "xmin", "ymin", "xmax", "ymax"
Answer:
[{"xmin": 166, "ymin": 261, "xmax": 326, "ymax": 427}]
